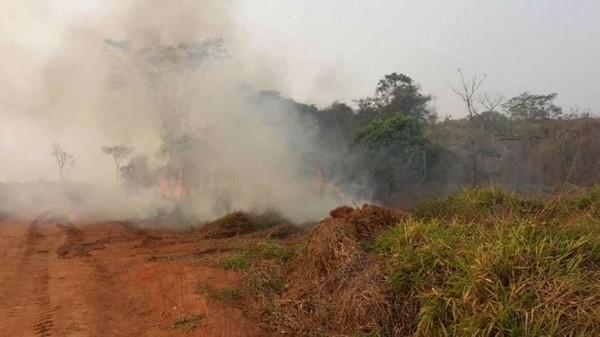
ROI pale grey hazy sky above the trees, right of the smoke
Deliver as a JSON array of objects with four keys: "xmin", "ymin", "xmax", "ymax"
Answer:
[{"xmin": 235, "ymin": 0, "xmax": 600, "ymax": 115}]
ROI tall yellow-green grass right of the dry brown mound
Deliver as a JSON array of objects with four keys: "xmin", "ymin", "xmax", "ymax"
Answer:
[{"xmin": 374, "ymin": 203, "xmax": 600, "ymax": 336}]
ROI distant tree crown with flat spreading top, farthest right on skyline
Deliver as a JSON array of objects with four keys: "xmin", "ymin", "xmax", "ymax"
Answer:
[{"xmin": 504, "ymin": 91, "xmax": 562, "ymax": 121}]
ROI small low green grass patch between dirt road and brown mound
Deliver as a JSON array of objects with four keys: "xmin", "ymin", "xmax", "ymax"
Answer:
[{"xmin": 224, "ymin": 241, "xmax": 299, "ymax": 270}]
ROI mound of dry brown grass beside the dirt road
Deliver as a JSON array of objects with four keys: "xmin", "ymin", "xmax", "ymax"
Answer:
[{"xmin": 232, "ymin": 205, "xmax": 401, "ymax": 336}]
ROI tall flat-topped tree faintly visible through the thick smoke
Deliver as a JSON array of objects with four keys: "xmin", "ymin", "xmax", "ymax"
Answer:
[{"xmin": 104, "ymin": 39, "xmax": 227, "ymax": 195}]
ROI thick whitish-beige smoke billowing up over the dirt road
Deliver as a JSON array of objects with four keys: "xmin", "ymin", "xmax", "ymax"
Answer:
[{"xmin": 0, "ymin": 0, "xmax": 360, "ymax": 221}]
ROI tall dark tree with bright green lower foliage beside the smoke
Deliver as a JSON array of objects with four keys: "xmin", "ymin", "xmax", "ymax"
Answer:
[{"xmin": 340, "ymin": 72, "xmax": 439, "ymax": 204}]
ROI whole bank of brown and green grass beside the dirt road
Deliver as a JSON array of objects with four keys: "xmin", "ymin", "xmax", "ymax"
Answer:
[{"xmin": 232, "ymin": 189, "xmax": 600, "ymax": 336}]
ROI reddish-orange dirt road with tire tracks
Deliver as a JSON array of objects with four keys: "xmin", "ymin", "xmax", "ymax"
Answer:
[{"xmin": 0, "ymin": 213, "xmax": 270, "ymax": 337}]
